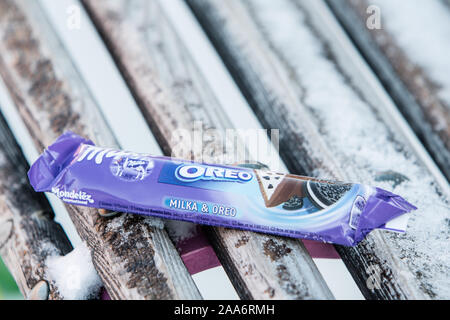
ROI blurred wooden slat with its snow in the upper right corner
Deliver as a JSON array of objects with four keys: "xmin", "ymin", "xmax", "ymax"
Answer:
[{"xmin": 328, "ymin": 0, "xmax": 450, "ymax": 179}]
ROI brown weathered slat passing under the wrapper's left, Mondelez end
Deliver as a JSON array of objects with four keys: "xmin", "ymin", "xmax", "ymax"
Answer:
[{"xmin": 0, "ymin": 0, "xmax": 200, "ymax": 299}]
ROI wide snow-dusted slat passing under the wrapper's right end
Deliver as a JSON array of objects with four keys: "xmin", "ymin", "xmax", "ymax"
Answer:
[{"xmin": 187, "ymin": 0, "xmax": 450, "ymax": 299}]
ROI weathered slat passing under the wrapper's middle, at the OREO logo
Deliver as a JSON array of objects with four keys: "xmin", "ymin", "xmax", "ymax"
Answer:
[{"xmin": 84, "ymin": 0, "xmax": 332, "ymax": 299}]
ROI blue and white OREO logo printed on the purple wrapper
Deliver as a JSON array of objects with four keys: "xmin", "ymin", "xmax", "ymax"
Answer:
[{"xmin": 175, "ymin": 164, "xmax": 253, "ymax": 182}]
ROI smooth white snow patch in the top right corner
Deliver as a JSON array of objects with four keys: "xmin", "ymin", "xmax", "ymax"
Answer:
[{"xmin": 371, "ymin": 0, "xmax": 450, "ymax": 107}]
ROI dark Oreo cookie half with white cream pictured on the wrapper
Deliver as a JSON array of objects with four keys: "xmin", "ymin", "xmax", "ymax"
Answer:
[{"xmin": 305, "ymin": 180, "xmax": 352, "ymax": 209}]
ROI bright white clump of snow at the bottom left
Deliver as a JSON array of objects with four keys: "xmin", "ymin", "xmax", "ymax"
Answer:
[{"xmin": 46, "ymin": 242, "xmax": 102, "ymax": 300}]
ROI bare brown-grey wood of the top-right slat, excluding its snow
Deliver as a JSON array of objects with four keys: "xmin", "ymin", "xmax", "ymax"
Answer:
[{"xmin": 327, "ymin": 0, "xmax": 450, "ymax": 179}]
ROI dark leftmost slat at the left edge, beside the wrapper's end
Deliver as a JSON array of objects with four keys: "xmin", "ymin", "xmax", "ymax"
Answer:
[{"xmin": 0, "ymin": 114, "xmax": 72, "ymax": 300}]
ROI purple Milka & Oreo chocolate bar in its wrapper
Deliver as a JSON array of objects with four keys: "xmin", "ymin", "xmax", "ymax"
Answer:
[{"xmin": 28, "ymin": 132, "xmax": 416, "ymax": 246}]
